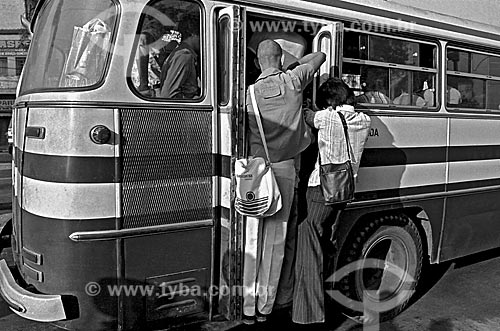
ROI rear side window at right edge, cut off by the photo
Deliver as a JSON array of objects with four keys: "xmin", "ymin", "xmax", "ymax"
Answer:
[{"xmin": 446, "ymin": 48, "xmax": 500, "ymax": 111}]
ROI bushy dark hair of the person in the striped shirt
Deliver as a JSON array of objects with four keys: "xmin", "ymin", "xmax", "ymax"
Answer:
[{"xmin": 316, "ymin": 77, "xmax": 356, "ymax": 109}]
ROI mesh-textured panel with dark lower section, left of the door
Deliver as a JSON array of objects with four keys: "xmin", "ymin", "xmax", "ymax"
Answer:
[{"xmin": 120, "ymin": 106, "xmax": 216, "ymax": 328}]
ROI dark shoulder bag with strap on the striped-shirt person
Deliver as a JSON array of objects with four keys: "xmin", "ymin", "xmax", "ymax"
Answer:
[{"xmin": 318, "ymin": 112, "xmax": 354, "ymax": 205}]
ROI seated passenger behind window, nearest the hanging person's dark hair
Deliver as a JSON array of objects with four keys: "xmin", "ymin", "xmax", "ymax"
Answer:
[{"xmin": 356, "ymin": 69, "xmax": 392, "ymax": 104}]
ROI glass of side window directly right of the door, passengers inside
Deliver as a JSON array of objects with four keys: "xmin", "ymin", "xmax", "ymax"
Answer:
[{"xmin": 342, "ymin": 30, "xmax": 437, "ymax": 108}]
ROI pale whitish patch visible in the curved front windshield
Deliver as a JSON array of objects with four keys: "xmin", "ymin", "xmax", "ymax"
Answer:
[{"xmin": 61, "ymin": 18, "xmax": 111, "ymax": 87}]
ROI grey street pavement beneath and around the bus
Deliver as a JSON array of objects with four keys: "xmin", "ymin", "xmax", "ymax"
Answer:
[{"xmin": 0, "ymin": 250, "xmax": 500, "ymax": 331}]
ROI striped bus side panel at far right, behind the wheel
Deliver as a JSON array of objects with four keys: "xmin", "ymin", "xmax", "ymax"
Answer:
[{"xmin": 441, "ymin": 118, "xmax": 500, "ymax": 260}]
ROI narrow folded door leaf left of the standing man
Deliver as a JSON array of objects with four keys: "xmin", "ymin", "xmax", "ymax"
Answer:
[{"xmin": 214, "ymin": 6, "xmax": 246, "ymax": 319}]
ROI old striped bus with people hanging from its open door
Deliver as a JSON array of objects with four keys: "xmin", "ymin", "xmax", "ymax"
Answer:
[{"xmin": 0, "ymin": 0, "xmax": 500, "ymax": 330}]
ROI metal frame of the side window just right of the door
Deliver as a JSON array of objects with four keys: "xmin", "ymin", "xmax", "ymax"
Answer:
[{"xmin": 342, "ymin": 28, "xmax": 441, "ymax": 112}]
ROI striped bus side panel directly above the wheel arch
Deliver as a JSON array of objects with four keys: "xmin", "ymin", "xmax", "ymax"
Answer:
[{"xmin": 354, "ymin": 114, "xmax": 448, "ymax": 261}]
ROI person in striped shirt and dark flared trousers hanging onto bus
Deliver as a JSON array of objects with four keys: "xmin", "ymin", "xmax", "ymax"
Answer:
[{"xmin": 292, "ymin": 78, "xmax": 371, "ymax": 324}]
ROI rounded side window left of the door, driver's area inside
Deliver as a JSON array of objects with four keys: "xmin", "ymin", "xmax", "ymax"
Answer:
[{"xmin": 130, "ymin": 0, "xmax": 205, "ymax": 100}]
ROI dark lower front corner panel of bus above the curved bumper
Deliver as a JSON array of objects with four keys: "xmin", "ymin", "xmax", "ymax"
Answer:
[{"xmin": 21, "ymin": 211, "xmax": 118, "ymax": 330}]
